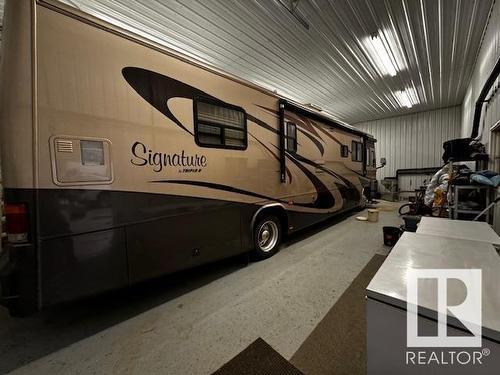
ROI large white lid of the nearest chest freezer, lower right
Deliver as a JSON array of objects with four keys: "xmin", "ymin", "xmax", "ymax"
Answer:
[{"xmin": 366, "ymin": 232, "xmax": 500, "ymax": 341}]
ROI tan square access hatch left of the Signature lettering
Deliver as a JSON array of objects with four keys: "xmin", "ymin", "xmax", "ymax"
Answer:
[{"xmin": 50, "ymin": 136, "xmax": 113, "ymax": 185}]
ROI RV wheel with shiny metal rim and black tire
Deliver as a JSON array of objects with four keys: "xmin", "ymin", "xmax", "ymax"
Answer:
[{"xmin": 253, "ymin": 216, "xmax": 281, "ymax": 259}]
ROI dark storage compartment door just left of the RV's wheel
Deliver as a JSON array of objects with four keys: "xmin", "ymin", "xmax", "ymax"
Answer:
[{"xmin": 126, "ymin": 204, "xmax": 243, "ymax": 283}]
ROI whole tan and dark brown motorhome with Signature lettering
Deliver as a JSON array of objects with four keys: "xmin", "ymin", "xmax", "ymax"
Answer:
[{"xmin": 0, "ymin": 0, "xmax": 375, "ymax": 314}]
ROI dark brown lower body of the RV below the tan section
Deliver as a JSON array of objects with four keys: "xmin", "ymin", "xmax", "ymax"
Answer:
[{"xmin": 0, "ymin": 189, "xmax": 360, "ymax": 315}]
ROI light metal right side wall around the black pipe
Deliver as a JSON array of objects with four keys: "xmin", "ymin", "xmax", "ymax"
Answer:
[{"xmin": 461, "ymin": 1, "xmax": 500, "ymax": 143}]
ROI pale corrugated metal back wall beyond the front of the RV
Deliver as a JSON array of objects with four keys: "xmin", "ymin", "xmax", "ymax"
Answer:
[{"xmin": 355, "ymin": 106, "xmax": 462, "ymax": 180}]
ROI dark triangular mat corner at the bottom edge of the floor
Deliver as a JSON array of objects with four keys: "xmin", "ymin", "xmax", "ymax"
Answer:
[{"xmin": 214, "ymin": 337, "xmax": 303, "ymax": 375}]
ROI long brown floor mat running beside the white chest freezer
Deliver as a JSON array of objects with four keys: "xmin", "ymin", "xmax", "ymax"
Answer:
[{"xmin": 290, "ymin": 255, "xmax": 386, "ymax": 375}]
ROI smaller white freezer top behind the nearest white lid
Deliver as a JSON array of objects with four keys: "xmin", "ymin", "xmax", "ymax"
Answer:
[{"xmin": 417, "ymin": 217, "xmax": 500, "ymax": 246}]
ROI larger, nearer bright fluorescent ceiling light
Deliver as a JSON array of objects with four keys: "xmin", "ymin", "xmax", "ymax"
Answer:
[{"xmin": 363, "ymin": 30, "xmax": 398, "ymax": 77}]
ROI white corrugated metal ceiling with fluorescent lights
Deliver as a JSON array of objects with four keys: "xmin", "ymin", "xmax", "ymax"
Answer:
[{"xmin": 0, "ymin": 0, "xmax": 494, "ymax": 123}]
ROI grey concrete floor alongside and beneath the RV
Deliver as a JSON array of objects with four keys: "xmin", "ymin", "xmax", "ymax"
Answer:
[{"xmin": 0, "ymin": 203, "xmax": 400, "ymax": 375}]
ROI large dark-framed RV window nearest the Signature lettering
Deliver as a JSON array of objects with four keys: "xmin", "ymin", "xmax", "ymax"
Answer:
[{"xmin": 194, "ymin": 100, "xmax": 247, "ymax": 150}]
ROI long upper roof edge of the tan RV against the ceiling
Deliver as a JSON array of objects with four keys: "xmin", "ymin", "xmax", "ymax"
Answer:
[{"xmin": 36, "ymin": 0, "xmax": 375, "ymax": 139}]
